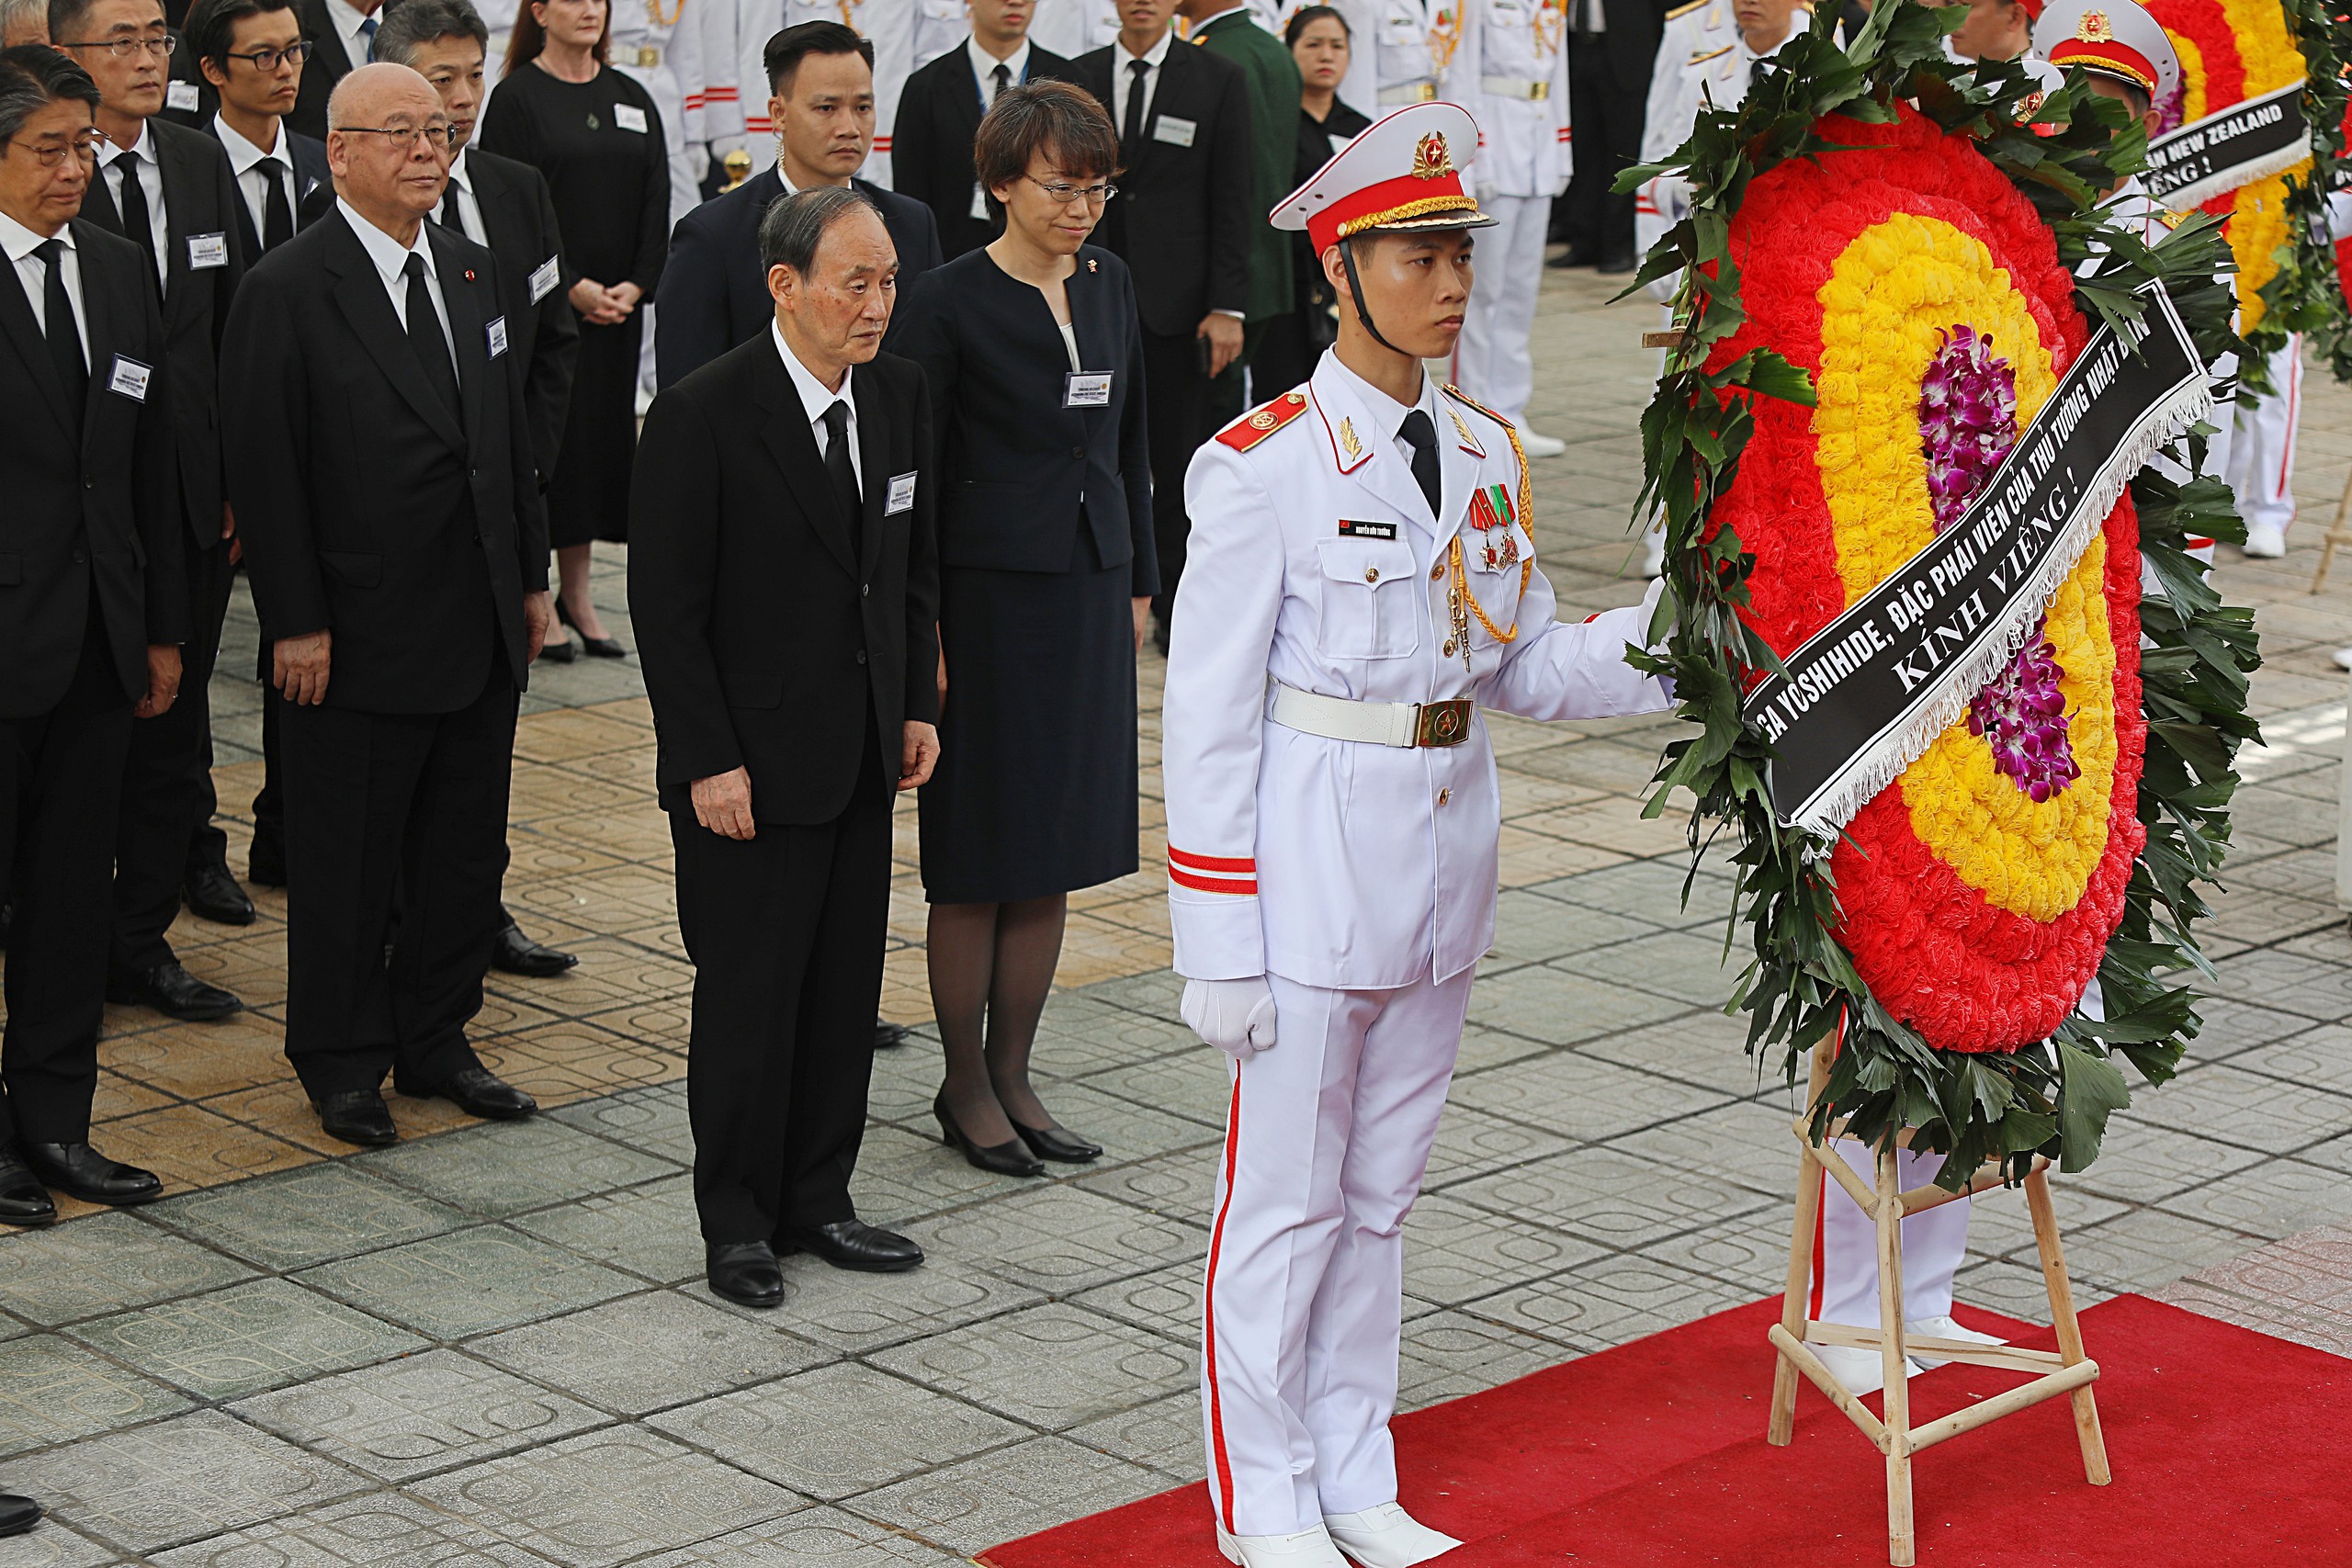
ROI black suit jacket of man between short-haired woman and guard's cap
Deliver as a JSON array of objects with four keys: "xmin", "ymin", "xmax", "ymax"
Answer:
[{"xmin": 1075, "ymin": 42, "xmax": 1265, "ymax": 336}]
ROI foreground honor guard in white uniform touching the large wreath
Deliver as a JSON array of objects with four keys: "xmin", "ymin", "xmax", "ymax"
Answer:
[{"xmin": 1162, "ymin": 104, "xmax": 1668, "ymax": 1568}]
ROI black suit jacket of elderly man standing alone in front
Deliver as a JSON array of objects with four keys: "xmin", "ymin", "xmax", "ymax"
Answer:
[{"xmin": 628, "ymin": 341, "xmax": 938, "ymax": 825}]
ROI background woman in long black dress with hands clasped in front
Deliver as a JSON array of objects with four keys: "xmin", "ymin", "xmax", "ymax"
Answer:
[{"xmin": 482, "ymin": 0, "xmax": 671, "ymax": 663}]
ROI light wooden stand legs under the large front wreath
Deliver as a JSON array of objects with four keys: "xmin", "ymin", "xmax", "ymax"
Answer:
[{"xmin": 1767, "ymin": 1046, "xmax": 2112, "ymax": 1568}]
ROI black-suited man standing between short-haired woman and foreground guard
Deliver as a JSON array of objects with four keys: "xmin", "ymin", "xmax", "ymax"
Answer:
[{"xmin": 1075, "ymin": 0, "xmax": 1265, "ymax": 651}]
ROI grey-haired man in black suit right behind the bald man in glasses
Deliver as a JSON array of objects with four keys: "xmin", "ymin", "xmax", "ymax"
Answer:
[{"xmin": 377, "ymin": 0, "xmax": 581, "ymax": 978}]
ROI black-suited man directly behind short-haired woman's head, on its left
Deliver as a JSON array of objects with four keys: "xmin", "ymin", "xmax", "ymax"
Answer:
[{"xmin": 889, "ymin": 0, "xmax": 1077, "ymax": 259}]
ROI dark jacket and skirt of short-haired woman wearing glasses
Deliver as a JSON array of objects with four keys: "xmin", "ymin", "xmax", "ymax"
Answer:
[{"xmin": 891, "ymin": 244, "xmax": 1159, "ymax": 903}]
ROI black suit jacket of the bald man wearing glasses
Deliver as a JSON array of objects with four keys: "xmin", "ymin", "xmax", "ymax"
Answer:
[{"xmin": 221, "ymin": 209, "xmax": 548, "ymax": 712}]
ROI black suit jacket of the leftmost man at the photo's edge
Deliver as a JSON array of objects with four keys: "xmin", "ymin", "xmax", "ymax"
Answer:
[{"xmin": 0, "ymin": 219, "xmax": 188, "ymax": 719}]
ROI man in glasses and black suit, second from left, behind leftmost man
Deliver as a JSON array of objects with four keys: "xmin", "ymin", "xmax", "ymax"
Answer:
[{"xmin": 50, "ymin": 0, "xmax": 254, "ymax": 1021}]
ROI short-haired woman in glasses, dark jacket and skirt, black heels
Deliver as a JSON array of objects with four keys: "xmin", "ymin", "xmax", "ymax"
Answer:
[{"xmin": 891, "ymin": 83, "xmax": 1159, "ymax": 1176}]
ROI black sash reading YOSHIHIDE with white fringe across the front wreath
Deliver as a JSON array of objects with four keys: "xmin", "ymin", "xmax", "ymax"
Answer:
[{"xmin": 1740, "ymin": 289, "xmax": 2213, "ymax": 837}]
